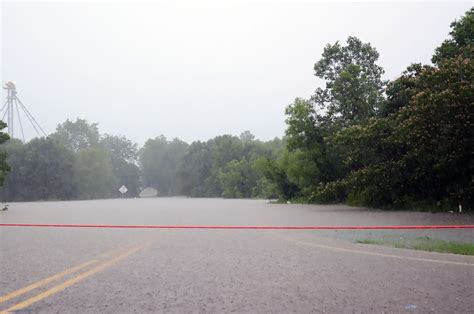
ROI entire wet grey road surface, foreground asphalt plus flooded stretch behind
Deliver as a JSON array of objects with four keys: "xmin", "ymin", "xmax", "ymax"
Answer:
[{"xmin": 0, "ymin": 198, "xmax": 474, "ymax": 313}]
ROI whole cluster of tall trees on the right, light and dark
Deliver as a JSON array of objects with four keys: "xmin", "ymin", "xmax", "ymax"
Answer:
[{"xmin": 267, "ymin": 9, "xmax": 474, "ymax": 210}]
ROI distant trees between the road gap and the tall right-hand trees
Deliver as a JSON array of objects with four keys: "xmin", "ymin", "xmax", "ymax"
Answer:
[{"xmin": 139, "ymin": 131, "xmax": 284, "ymax": 198}]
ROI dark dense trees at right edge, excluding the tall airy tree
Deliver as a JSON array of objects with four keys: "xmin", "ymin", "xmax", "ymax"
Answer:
[{"xmin": 314, "ymin": 10, "xmax": 474, "ymax": 209}]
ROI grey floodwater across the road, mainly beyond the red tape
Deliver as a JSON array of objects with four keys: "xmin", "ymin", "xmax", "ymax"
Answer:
[{"xmin": 0, "ymin": 197, "xmax": 474, "ymax": 243}]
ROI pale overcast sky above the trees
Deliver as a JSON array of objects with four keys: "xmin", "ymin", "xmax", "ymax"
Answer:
[{"xmin": 0, "ymin": 1, "xmax": 472, "ymax": 144}]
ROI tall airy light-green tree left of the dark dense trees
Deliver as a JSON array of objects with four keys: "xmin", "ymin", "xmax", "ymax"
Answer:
[{"xmin": 279, "ymin": 37, "xmax": 385, "ymax": 200}]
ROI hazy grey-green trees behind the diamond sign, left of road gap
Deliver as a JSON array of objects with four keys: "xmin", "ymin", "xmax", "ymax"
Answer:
[{"xmin": 0, "ymin": 119, "xmax": 140, "ymax": 201}]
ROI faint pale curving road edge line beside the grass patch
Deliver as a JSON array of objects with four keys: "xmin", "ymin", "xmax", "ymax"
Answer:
[{"xmin": 279, "ymin": 236, "xmax": 474, "ymax": 267}]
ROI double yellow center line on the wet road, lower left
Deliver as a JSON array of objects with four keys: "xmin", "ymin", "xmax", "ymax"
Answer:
[{"xmin": 0, "ymin": 243, "xmax": 149, "ymax": 314}]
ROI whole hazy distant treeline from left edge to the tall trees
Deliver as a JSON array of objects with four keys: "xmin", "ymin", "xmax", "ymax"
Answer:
[{"xmin": 0, "ymin": 119, "xmax": 284, "ymax": 201}]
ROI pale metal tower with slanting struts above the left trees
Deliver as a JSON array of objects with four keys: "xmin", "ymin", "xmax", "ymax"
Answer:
[{"xmin": 0, "ymin": 81, "xmax": 47, "ymax": 141}]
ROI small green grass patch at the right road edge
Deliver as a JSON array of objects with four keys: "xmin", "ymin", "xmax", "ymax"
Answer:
[{"xmin": 355, "ymin": 237, "xmax": 474, "ymax": 255}]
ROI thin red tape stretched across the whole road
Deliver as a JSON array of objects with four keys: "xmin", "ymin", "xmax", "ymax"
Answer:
[{"xmin": 0, "ymin": 223, "xmax": 474, "ymax": 230}]
